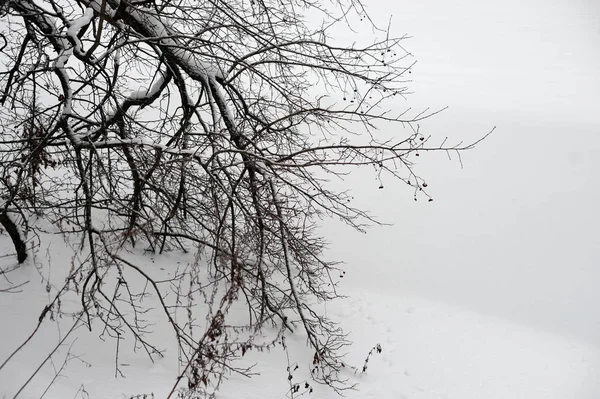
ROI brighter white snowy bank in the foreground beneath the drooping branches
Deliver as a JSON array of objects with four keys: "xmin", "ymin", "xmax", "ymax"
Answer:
[{"xmin": 0, "ymin": 250, "xmax": 600, "ymax": 399}]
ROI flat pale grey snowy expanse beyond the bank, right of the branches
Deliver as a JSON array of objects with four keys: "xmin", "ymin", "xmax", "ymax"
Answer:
[{"xmin": 326, "ymin": 0, "xmax": 600, "ymax": 346}]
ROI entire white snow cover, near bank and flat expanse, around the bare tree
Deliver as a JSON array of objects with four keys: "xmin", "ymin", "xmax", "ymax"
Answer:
[{"xmin": 0, "ymin": 0, "xmax": 600, "ymax": 399}]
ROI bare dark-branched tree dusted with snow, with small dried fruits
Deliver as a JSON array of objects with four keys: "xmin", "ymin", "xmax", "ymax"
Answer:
[{"xmin": 0, "ymin": 0, "xmax": 488, "ymax": 395}]
